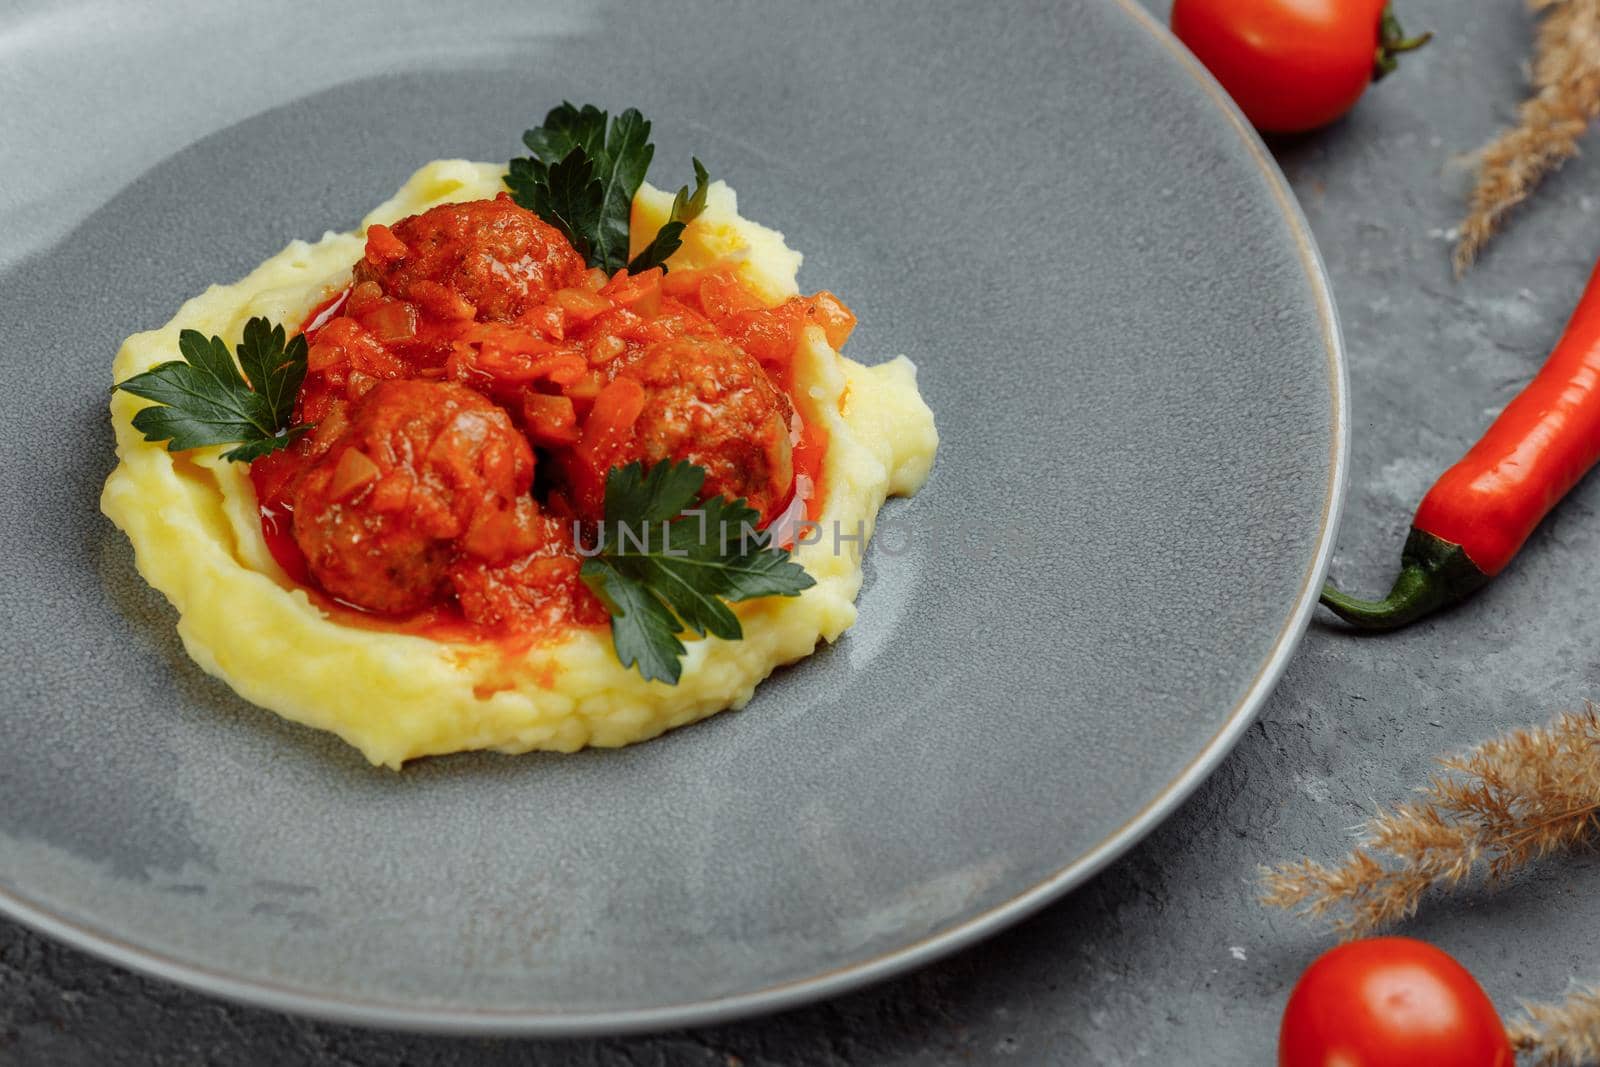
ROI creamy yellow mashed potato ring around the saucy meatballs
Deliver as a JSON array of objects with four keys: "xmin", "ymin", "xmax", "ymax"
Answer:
[{"xmin": 101, "ymin": 160, "xmax": 938, "ymax": 768}]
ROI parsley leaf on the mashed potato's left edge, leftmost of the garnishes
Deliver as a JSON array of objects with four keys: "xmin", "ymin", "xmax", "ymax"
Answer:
[{"xmin": 117, "ymin": 318, "xmax": 310, "ymax": 462}]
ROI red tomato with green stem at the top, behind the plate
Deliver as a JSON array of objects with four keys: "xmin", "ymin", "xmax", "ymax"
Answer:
[{"xmin": 1173, "ymin": 0, "xmax": 1429, "ymax": 133}]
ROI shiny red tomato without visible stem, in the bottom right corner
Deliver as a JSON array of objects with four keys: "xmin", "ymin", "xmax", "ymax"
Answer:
[{"xmin": 1278, "ymin": 937, "xmax": 1512, "ymax": 1067}]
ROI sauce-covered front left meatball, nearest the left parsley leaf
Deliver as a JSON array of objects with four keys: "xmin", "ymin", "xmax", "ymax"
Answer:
[{"xmin": 294, "ymin": 379, "xmax": 538, "ymax": 613}]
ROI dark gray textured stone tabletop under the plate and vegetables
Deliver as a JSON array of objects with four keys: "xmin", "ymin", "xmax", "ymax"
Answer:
[{"xmin": 9, "ymin": 0, "xmax": 1600, "ymax": 1067}]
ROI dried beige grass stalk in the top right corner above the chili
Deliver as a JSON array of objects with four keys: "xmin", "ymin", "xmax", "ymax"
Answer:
[{"xmin": 1456, "ymin": 0, "xmax": 1600, "ymax": 274}]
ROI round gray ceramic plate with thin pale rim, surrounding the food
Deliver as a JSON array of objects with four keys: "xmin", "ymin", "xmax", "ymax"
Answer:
[{"xmin": 0, "ymin": 0, "xmax": 1346, "ymax": 1033}]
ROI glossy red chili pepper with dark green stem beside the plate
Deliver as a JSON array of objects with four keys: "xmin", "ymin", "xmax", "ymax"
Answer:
[{"xmin": 1322, "ymin": 255, "xmax": 1600, "ymax": 630}]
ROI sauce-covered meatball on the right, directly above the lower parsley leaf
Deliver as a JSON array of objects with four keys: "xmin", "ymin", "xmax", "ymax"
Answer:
[{"xmin": 568, "ymin": 338, "xmax": 795, "ymax": 518}]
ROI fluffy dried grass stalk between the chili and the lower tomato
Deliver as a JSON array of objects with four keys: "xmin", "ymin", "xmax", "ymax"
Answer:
[{"xmin": 1261, "ymin": 704, "xmax": 1600, "ymax": 937}]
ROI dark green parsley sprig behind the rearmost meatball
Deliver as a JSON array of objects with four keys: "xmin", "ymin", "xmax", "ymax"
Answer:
[{"xmin": 506, "ymin": 102, "xmax": 710, "ymax": 274}]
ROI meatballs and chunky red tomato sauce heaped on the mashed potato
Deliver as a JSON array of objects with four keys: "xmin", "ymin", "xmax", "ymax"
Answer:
[{"xmin": 251, "ymin": 197, "xmax": 854, "ymax": 645}]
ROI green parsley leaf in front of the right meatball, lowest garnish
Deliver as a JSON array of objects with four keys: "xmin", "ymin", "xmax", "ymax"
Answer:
[{"xmin": 579, "ymin": 462, "xmax": 816, "ymax": 685}]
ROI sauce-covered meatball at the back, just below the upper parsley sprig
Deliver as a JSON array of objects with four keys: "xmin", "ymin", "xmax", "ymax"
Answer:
[{"xmin": 355, "ymin": 195, "xmax": 584, "ymax": 322}]
